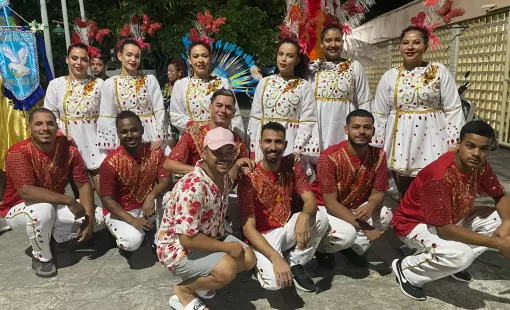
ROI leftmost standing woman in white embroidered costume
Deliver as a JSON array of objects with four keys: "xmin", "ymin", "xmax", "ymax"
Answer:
[{"xmin": 44, "ymin": 43, "xmax": 105, "ymax": 188}]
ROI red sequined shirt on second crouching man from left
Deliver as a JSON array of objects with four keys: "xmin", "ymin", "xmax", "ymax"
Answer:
[{"xmin": 99, "ymin": 143, "xmax": 170, "ymax": 215}]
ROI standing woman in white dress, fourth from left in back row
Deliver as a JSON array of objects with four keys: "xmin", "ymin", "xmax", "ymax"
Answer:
[{"xmin": 247, "ymin": 38, "xmax": 319, "ymax": 167}]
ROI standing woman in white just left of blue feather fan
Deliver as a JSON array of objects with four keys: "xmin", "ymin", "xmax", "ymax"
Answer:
[{"xmin": 170, "ymin": 40, "xmax": 244, "ymax": 136}]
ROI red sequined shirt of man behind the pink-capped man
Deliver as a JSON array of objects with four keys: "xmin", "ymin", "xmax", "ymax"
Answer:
[{"xmin": 168, "ymin": 125, "xmax": 247, "ymax": 166}]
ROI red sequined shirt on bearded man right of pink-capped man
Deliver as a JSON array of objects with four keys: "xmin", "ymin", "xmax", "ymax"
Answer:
[{"xmin": 238, "ymin": 156, "xmax": 311, "ymax": 233}]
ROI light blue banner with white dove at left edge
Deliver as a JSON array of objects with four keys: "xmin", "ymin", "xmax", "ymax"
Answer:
[{"xmin": 0, "ymin": 29, "xmax": 39, "ymax": 101}]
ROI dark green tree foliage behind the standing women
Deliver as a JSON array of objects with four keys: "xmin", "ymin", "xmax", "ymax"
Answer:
[{"xmin": 11, "ymin": 0, "xmax": 285, "ymax": 75}]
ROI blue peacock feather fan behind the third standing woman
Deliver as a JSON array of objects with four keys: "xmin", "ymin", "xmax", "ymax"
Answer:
[{"xmin": 181, "ymin": 35, "xmax": 258, "ymax": 97}]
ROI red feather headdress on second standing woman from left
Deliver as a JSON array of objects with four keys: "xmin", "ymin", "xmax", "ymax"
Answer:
[{"xmin": 117, "ymin": 14, "xmax": 162, "ymax": 49}]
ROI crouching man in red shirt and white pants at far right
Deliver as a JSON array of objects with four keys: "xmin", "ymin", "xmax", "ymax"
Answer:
[{"xmin": 392, "ymin": 121, "xmax": 510, "ymax": 300}]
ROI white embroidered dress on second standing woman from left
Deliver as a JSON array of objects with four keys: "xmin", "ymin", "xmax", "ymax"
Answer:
[{"xmin": 97, "ymin": 74, "xmax": 167, "ymax": 150}]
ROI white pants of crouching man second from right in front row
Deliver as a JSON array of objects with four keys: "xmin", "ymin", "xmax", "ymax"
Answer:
[{"xmin": 317, "ymin": 206, "xmax": 393, "ymax": 255}]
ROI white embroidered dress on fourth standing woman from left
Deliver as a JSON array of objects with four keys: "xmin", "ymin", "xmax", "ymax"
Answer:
[{"xmin": 246, "ymin": 75, "xmax": 320, "ymax": 162}]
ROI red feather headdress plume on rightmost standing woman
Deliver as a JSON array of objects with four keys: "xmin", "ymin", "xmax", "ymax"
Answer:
[{"xmin": 411, "ymin": 0, "xmax": 466, "ymax": 49}]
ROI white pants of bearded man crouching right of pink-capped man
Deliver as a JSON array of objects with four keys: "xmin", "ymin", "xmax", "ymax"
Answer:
[{"xmin": 255, "ymin": 212, "xmax": 329, "ymax": 290}]
